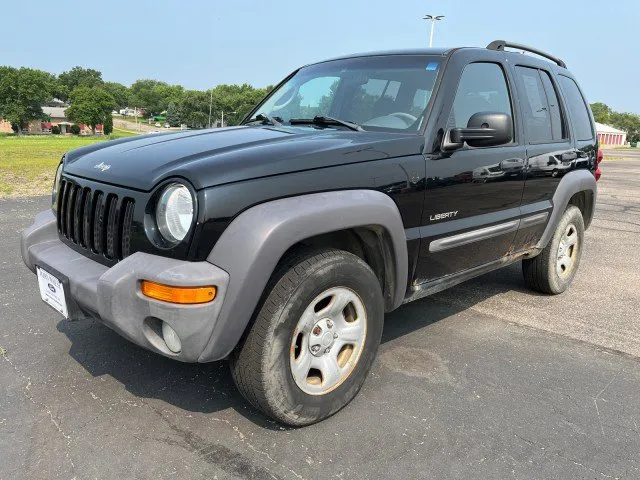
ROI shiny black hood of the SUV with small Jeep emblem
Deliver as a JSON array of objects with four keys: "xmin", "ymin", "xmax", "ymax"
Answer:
[{"xmin": 64, "ymin": 126, "xmax": 424, "ymax": 191}]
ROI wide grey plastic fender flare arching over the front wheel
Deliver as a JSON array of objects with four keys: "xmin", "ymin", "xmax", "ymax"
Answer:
[{"xmin": 199, "ymin": 190, "xmax": 408, "ymax": 362}]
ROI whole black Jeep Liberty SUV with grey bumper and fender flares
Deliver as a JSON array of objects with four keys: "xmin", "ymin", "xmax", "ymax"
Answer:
[{"xmin": 21, "ymin": 41, "xmax": 601, "ymax": 425}]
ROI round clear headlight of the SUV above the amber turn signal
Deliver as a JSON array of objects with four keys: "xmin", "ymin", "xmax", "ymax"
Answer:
[{"xmin": 156, "ymin": 183, "xmax": 193, "ymax": 243}]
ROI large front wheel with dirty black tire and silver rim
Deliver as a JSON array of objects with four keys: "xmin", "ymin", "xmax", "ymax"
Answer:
[{"xmin": 230, "ymin": 249, "xmax": 384, "ymax": 426}]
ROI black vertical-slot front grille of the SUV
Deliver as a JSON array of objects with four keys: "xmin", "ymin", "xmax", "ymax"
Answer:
[{"xmin": 57, "ymin": 180, "xmax": 135, "ymax": 261}]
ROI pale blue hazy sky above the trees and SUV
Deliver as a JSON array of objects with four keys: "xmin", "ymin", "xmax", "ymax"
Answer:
[{"xmin": 5, "ymin": 0, "xmax": 640, "ymax": 113}]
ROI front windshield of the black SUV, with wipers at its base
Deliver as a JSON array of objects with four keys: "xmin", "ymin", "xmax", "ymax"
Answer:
[{"xmin": 249, "ymin": 55, "xmax": 442, "ymax": 133}]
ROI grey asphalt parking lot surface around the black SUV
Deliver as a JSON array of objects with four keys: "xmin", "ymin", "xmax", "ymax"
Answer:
[{"xmin": 0, "ymin": 154, "xmax": 640, "ymax": 479}]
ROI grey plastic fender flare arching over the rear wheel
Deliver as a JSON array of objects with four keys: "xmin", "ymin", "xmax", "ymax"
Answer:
[{"xmin": 536, "ymin": 170, "xmax": 598, "ymax": 250}]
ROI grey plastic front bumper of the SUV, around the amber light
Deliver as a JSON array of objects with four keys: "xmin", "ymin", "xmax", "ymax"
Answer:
[{"xmin": 21, "ymin": 210, "xmax": 229, "ymax": 362}]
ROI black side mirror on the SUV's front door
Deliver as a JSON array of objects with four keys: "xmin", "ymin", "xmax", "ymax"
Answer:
[{"xmin": 446, "ymin": 112, "xmax": 513, "ymax": 150}]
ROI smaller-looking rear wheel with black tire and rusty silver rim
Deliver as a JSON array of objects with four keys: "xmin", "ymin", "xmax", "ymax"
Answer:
[{"xmin": 522, "ymin": 205, "xmax": 584, "ymax": 295}]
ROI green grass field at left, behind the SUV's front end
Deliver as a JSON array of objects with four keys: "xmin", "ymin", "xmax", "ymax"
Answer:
[{"xmin": 0, "ymin": 129, "xmax": 135, "ymax": 198}]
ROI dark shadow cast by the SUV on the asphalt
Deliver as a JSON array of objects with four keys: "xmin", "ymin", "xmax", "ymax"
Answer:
[{"xmin": 57, "ymin": 264, "xmax": 526, "ymax": 430}]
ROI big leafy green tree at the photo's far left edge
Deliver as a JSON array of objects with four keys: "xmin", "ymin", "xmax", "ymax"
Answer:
[{"xmin": 0, "ymin": 67, "xmax": 55, "ymax": 135}]
